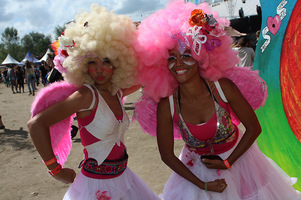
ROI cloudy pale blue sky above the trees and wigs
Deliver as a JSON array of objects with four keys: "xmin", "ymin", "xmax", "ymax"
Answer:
[{"xmin": 0, "ymin": 0, "xmax": 168, "ymax": 39}]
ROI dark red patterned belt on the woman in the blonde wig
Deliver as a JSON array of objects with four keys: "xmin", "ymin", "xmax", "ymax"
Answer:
[{"xmin": 81, "ymin": 151, "xmax": 128, "ymax": 179}]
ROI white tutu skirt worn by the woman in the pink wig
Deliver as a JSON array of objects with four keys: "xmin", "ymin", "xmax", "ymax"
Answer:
[{"xmin": 160, "ymin": 130, "xmax": 301, "ymax": 200}]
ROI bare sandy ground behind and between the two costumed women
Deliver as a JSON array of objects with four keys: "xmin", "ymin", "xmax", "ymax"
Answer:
[{"xmin": 0, "ymin": 83, "xmax": 183, "ymax": 200}]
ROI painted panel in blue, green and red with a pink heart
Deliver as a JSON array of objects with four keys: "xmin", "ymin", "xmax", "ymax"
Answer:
[{"xmin": 254, "ymin": 0, "xmax": 301, "ymax": 191}]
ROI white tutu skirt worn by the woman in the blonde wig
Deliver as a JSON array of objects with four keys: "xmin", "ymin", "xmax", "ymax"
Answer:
[{"xmin": 63, "ymin": 168, "xmax": 159, "ymax": 200}]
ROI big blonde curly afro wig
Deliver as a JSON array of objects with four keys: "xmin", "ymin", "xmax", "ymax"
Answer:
[{"xmin": 63, "ymin": 4, "xmax": 138, "ymax": 94}]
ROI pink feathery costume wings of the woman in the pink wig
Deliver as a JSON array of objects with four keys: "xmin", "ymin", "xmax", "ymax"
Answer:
[{"xmin": 133, "ymin": 67, "xmax": 267, "ymax": 139}]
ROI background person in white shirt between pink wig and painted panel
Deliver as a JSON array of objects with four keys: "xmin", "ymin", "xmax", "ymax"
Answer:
[{"xmin": 237, "ymin": 36, "xmax": 255, "ymax": 69}]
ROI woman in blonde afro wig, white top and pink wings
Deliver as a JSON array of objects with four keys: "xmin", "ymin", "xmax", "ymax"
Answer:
[{"xmin": 28, "ymin": 4, "xmax": 158, "ymax": 200}]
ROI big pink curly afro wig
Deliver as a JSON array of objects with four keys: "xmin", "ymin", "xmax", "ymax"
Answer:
[{"xmin": 135, "ymin": 0, "xmax": 238, "ymax": 101}]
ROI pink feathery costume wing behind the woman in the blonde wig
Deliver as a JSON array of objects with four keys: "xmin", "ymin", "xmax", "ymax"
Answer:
[{"xmin": 31, "ymin": 81, "xmax": 77, "ymax": 166}]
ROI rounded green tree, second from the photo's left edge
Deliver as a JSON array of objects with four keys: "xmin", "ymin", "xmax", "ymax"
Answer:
[{"xmin": 21, "ymin": 32, "xmax": 51, "ymax": 59}]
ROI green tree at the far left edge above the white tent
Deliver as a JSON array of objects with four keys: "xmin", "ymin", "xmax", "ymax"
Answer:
[{"xmin": 0, "ymin": 27, "xmax": 22, "ymax": 61}]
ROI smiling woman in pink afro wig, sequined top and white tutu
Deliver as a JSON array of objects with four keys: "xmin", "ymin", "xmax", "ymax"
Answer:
[{"xmin": 135, "ymin": 0, "xmax": 300, "ymax": 200}]
